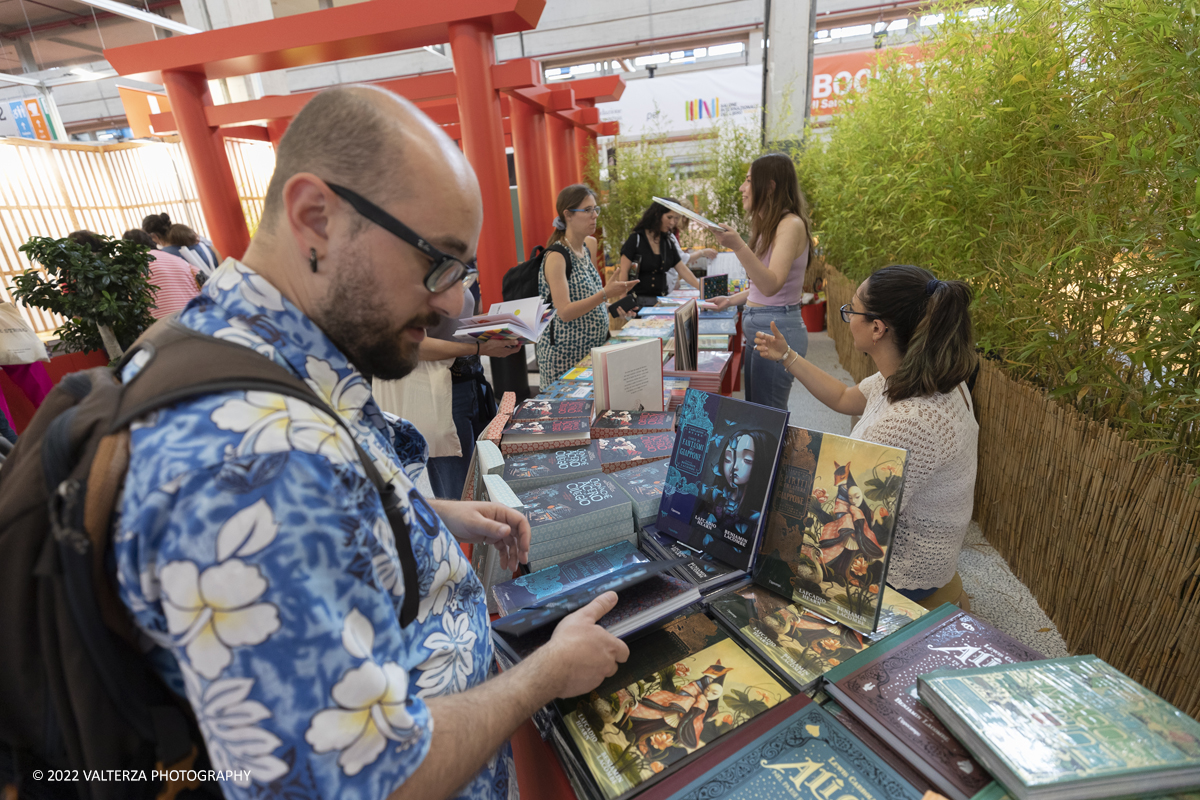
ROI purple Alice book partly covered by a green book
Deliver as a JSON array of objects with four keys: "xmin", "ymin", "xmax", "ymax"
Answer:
[{"xmin": 824, "ymin": 603, "xmax": 1042, "ymax": 800}]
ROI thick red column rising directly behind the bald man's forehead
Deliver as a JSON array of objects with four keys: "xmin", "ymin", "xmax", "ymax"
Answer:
[{"xmin": 450, "ymin": 19, "xmax": 517, "ymax": 308}]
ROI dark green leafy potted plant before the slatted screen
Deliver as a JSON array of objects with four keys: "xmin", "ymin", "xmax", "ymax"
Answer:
[{"xmin": 12, "ymin": 236, "xmax": 157, "ymax": 360}]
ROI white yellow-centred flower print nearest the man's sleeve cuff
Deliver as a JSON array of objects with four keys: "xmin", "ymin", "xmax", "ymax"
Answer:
[{"xmin": 304, "ymin": 608, "xmax": 422, "ymax": 775}]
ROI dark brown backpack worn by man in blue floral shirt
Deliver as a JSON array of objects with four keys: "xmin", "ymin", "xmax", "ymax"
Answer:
[{"xmin": 0, "ymin": 318, "xmax": 420, "ymax": 800}]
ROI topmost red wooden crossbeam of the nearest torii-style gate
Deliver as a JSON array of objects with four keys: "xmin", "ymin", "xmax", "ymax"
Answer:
[{"xmin": 104, "ymin": 0, "xmax": 546, "ymax": 83}]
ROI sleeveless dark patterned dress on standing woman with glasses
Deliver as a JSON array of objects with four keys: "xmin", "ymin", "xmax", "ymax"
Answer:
[{"xmin": 535, "ymin": 242, "xmax": 608, "ymax": 391}]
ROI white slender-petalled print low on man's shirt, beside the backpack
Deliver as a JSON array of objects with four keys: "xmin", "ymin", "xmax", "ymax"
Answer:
[{"xmin": 180, "ymin": 663, "xmax": 288, "ymax": 788}]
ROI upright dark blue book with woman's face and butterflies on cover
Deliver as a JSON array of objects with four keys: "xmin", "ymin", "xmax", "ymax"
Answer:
[{"xmin": 658, "ymin": 389, "xmax": 787, "ymax": 572}]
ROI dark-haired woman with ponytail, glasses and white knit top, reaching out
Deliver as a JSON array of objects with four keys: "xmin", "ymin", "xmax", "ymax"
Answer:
[{"xmin": 755, "ymin": 265, "xmax": 979, "ymax": 604}]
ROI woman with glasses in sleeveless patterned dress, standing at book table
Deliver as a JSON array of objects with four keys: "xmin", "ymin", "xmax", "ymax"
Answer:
[{"xmin": 535, "ymin": 184, "xmax": 637, "ymax": 391}]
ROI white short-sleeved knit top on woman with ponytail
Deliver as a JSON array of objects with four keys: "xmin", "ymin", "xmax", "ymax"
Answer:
[{"xmin": 850, "ymin": 373, "xmax": 979, "ymax": 589}]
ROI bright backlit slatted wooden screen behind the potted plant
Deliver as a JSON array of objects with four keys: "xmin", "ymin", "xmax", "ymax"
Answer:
[{"xmin": 0, "ymin": 138, "xmax": 275, "ymax": 333}]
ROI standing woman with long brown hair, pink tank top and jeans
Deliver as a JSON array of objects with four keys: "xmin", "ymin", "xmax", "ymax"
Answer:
[{"xmin": 713, "ymin": 152, "xmax": 812, "ymax": 411}]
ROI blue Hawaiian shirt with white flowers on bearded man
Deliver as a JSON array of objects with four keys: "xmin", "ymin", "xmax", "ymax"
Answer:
[{"xmin": 113, "ymin": 259, "xmax": 516, "ymax": 800}]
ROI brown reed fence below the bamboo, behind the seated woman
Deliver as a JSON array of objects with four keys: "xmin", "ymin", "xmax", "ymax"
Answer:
[{"xmin": 826, "ymin": 269, "xmax": 1200, "ymax": 717}]
